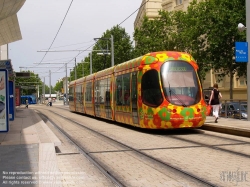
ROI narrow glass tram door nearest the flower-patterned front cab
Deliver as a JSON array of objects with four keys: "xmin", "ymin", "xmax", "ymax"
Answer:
[{"xmin": 131, "ymin": 72, "xmax": 138, "ymax": 124}]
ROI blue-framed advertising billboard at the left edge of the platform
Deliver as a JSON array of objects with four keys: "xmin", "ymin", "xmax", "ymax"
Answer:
[{"xmin": 0, "ymin": 69, "xmax": 9, "ymax": 132}]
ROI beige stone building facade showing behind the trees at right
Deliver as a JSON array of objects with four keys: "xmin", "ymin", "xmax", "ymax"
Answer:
[{"xmin": 134, "ymin": 0, "xmax": 247, "ymax": 100}]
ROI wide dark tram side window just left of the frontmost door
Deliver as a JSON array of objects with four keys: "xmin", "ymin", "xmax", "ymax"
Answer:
[{"xmin": 116, "ymin": 73, "xmax": 130, "ymax": 106}]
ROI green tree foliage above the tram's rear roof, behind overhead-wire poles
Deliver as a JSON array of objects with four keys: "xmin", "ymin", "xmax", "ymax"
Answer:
[{"xmin": 70, "ymin": 25, "xmax": 134, "ymax": 81}]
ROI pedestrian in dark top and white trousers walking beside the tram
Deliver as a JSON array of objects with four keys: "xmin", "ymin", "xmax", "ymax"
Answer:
[{"xmin": 209, "ymin": 83, "xmax": 222, "ymax": 123}]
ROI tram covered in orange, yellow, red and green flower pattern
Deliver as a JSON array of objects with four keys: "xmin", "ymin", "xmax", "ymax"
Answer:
[{"xmin": 69, "ymin": 51, "xmax": 207, "ymax": 129}]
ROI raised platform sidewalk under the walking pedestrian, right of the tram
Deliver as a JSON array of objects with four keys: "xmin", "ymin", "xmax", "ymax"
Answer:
[{"xmin": 201, "ymin": 116, "xmax": 250, "ymax": 137}]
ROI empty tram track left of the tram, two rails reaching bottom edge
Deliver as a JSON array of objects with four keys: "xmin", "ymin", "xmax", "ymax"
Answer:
[{"xmin": 36, "ymin": 108, "xmax": 217, "ymax": 186}]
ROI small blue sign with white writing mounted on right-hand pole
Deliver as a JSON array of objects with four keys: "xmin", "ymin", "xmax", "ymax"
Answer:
[{"xmin": 235, "ymin": 42, "xmax": 248, "ymax": 62}]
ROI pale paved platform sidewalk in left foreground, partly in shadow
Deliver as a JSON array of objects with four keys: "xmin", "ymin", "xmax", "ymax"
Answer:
[{"xmin": 0, "ymin": 106, "xmax": 61, "ymax": 187}]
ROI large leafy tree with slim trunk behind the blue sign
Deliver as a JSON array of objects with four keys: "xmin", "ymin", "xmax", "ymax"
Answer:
[{"xmin": 185, "ymin": 0, "xmax": 246, "ymax": 99}]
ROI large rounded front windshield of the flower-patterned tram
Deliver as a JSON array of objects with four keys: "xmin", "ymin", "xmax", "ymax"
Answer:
[{"xmin": 161, "ymin": 61, "xmax": 201, "ymax": 107}]
